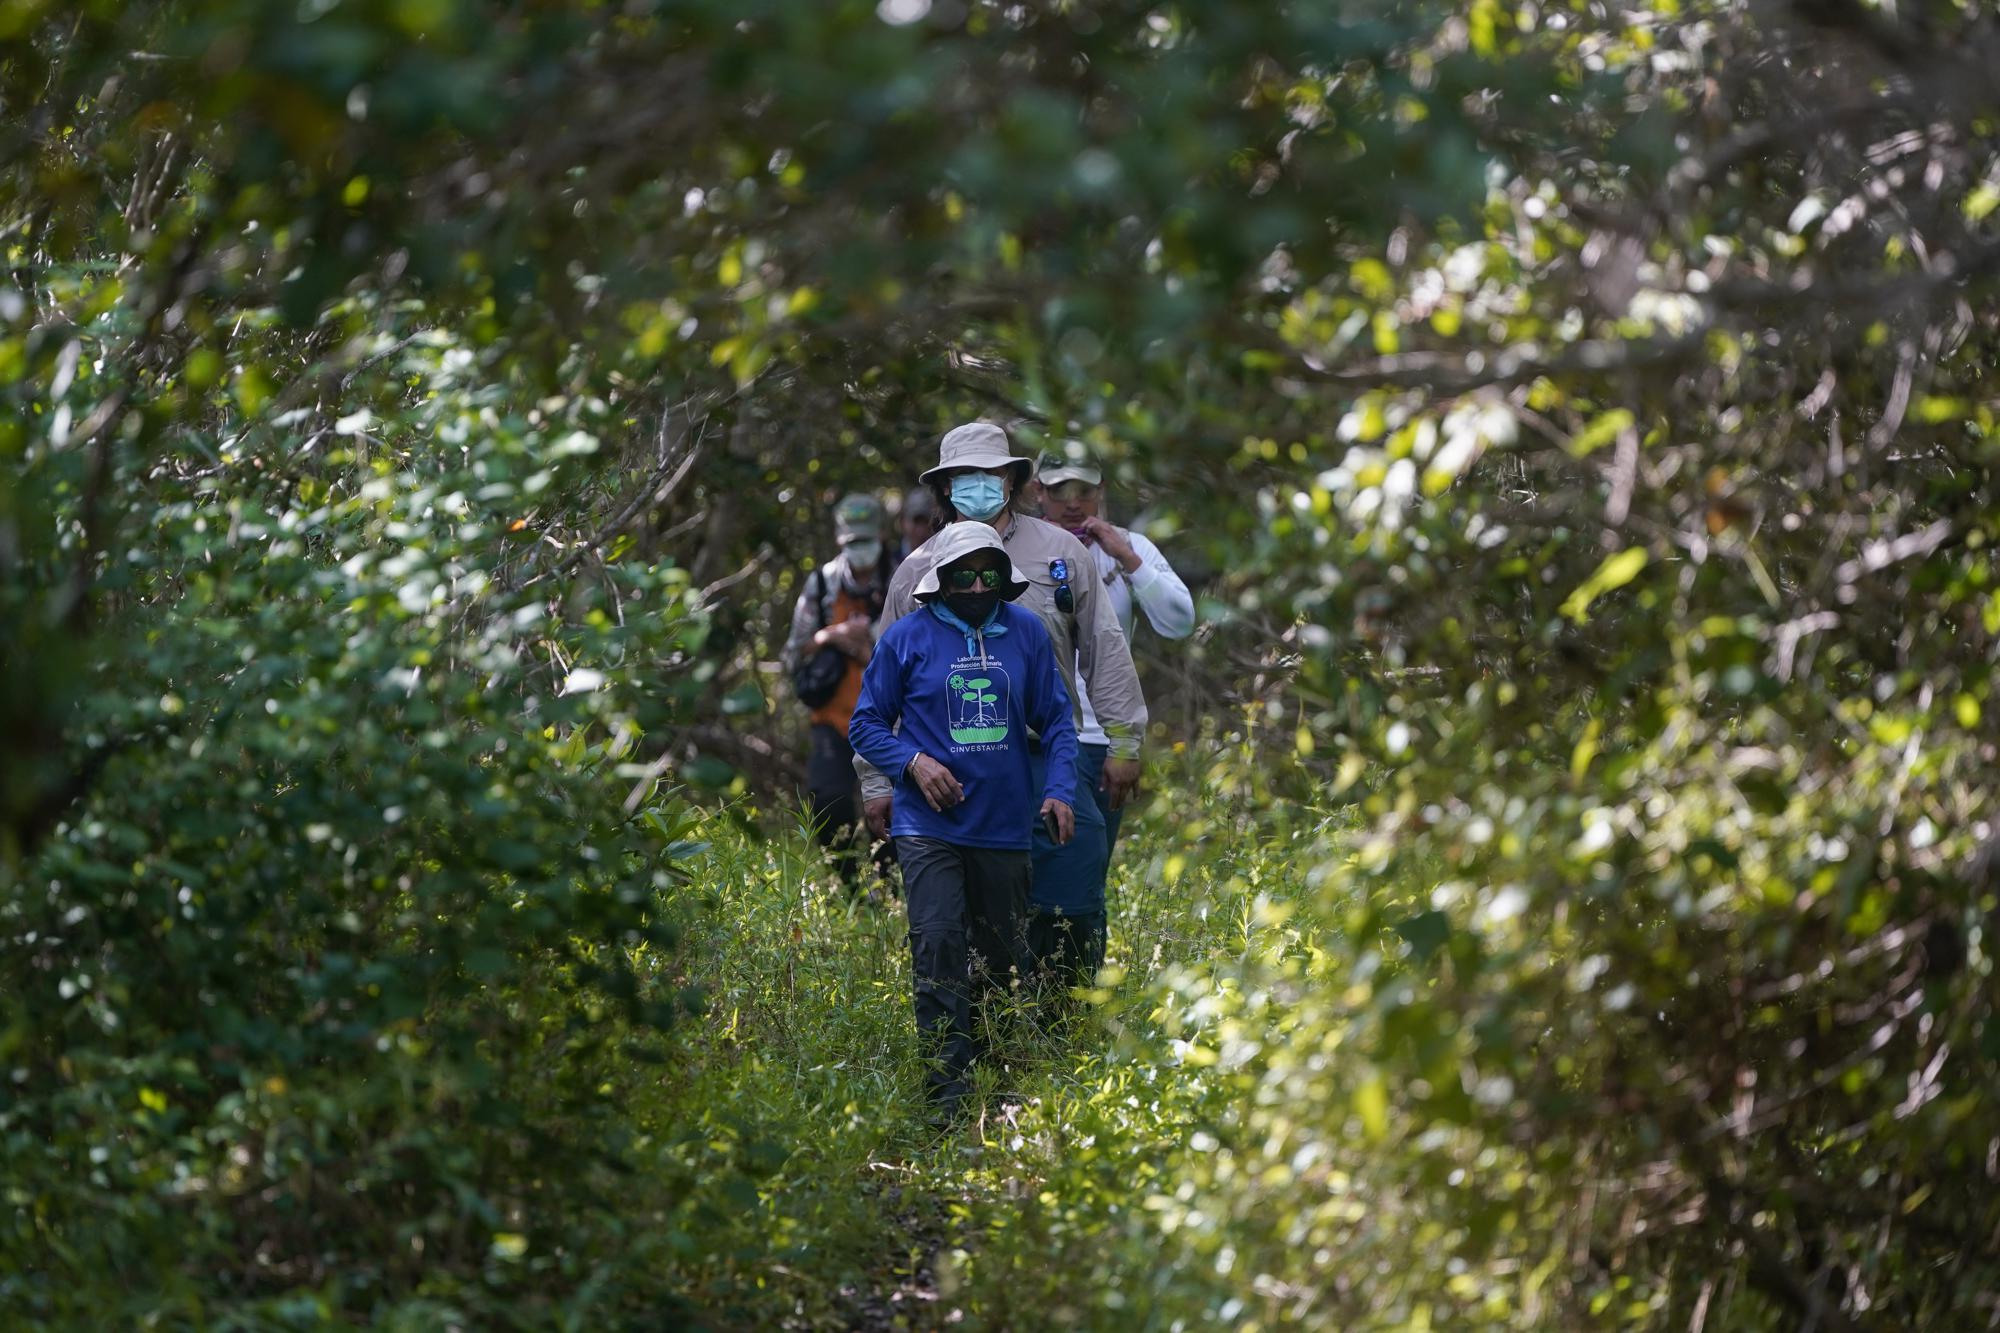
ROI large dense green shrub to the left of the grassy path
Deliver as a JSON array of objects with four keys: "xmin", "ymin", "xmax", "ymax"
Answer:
[{"xmin": 0, "ymin": 312, "xmax": 720, "ymax": 1323}]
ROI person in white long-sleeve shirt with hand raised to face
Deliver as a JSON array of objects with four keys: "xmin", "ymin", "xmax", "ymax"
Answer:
[{"xmin": 1034, "ymin": 444, "xmax": 1194, "ymax": 859}]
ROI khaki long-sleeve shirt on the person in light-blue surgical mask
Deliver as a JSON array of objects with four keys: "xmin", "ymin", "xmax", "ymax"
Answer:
[{"xmin": 854, "ymin": 514, "xmax": 1146, "ymax": 801}]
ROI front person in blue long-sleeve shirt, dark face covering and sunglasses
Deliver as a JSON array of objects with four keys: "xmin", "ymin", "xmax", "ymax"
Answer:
[{"xmin": 848, "ymin": 522, "xmax": 1076, "ymax": 1119}]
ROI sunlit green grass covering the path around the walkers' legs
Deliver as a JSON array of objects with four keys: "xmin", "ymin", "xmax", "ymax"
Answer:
[{"xmin": 624, "ymin": 752, "xmax": 1360, "ymax": 1327}]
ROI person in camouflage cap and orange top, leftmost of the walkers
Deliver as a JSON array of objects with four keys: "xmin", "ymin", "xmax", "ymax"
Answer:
[{"xmin": 782, "ymin": 494, "xmax": 888, "ymax": 889}]
